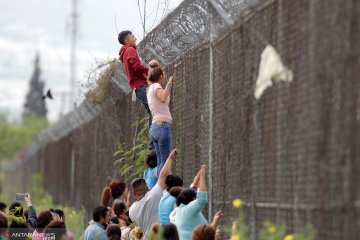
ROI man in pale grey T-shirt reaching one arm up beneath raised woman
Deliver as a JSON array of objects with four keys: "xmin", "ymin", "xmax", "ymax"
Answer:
[{"xmin": 129, "ymin": 149, "xmax": 178, "ymax": 236}]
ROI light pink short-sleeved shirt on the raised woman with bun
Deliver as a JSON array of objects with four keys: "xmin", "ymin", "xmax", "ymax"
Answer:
[{"xmin": 147, "ymin": 83, "xmax": 172, "ymax": 123}]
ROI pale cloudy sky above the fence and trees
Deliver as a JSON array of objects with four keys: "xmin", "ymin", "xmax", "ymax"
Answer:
[{"xmin": 0, "ymin": 0, "xmax": 182, "ymax": 122}]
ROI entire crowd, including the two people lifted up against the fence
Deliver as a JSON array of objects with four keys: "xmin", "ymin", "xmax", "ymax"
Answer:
[{"xmin": 0, "ymin": 31, "xmax": 222, "ymax": 240}]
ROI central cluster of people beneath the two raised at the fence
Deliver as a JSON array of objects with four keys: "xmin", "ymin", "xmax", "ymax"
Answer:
[{"xmin": 87, "ymin": 149, "xmax": 222, "ymax": 240}]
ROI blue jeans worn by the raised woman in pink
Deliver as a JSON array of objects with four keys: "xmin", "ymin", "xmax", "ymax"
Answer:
[{"xmin": 150, "ymin": 122, "xmax": 172, "ymax": 175}]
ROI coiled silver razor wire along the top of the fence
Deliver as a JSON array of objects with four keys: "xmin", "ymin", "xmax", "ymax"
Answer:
[{"xmin": 14, "ymin": 0, "xmax": 253, "ymax": 161}]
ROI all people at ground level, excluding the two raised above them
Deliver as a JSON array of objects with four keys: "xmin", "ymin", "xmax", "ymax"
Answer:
[{"xmin": 0, "ymin": 149, "xmax": 222, "ymax": 240}]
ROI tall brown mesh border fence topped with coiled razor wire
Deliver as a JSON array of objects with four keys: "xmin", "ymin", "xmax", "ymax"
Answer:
[{"xmin": 1, "ymin": 0, "xmax": 360, "ymax": 240}]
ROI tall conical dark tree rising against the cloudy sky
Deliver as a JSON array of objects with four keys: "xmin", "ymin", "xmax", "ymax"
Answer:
[{"xmin": 23, "ymin": 53, "xmax": 47, "ymax": 118}]
